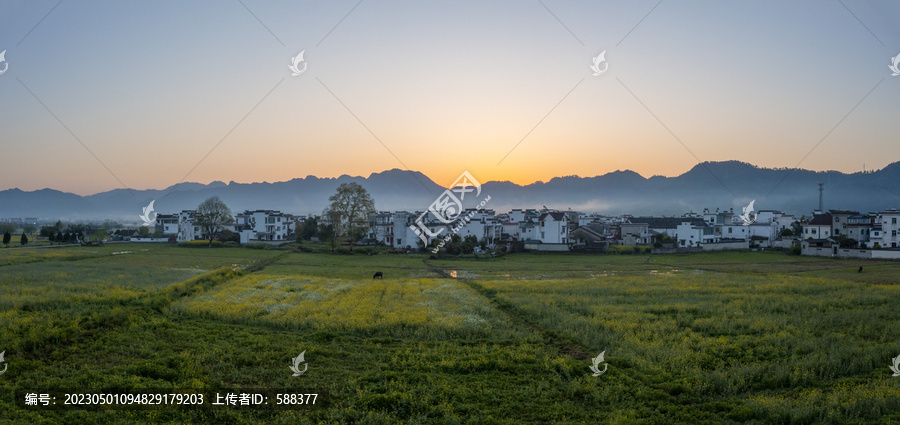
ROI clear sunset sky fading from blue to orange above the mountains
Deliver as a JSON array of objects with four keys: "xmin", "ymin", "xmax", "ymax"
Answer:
[{"xmin": 0, "ymin": 0, "xmax": 900, "ymax": 195}]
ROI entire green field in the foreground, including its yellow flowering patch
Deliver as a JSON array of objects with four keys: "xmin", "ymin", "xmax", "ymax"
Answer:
[{"xmin": 0, "ymin": 244, "xmax": 900, "ymax": 424}]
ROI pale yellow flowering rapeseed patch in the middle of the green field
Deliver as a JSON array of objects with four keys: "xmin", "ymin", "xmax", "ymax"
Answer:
[{"xmin": 171, "ymin": 274, "xmax": 511, "ymax": 338}]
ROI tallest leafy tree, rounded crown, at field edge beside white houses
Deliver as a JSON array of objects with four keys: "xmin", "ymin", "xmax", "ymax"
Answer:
[{"xmin": 328, "ymin": 183, "xmax": 375, "ymax": 252}]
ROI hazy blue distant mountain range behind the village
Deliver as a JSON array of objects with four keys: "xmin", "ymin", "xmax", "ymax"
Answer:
[{"xmin": 0, "ymin": 161, "xmax": 900, "ymax": 222}]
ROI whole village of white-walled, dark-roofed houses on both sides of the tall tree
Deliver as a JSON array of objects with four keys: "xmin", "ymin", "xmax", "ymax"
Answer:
[{"xmin": 137, "ymin": 202, "xmax": 900, "ymax": 259}]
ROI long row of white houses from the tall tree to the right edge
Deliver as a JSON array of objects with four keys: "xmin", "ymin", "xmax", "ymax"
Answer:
[{"xmin": 369, "ymin": 205, "xmax": 900, "ymax": 255}]
